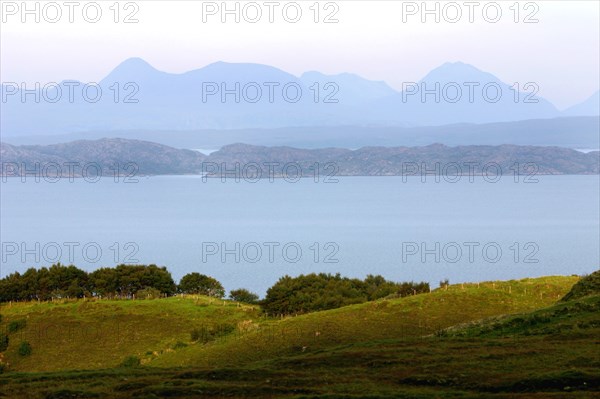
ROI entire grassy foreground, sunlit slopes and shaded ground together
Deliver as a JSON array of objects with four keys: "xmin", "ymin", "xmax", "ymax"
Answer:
[{"xmin": 0, "ymin": 276, "xmax": 600, "ymax": 398}]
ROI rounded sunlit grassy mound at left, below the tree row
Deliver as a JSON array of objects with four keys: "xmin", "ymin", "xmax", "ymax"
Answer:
[{"xmin": 0, "ymin": 297, "xmax": 259, "ymax": 371}]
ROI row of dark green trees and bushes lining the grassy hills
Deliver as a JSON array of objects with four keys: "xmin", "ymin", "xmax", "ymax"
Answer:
[{"xmin": 0, "ymin": 263, "xmax": 429, "ymax": 314}]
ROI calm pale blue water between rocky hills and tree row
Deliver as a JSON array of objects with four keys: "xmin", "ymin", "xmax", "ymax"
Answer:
[{"xmin": 0, "ymin": 176, "xmax": 600, "ymax": 294}]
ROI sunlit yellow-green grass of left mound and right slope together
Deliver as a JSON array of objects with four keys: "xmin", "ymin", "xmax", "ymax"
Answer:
[{"xmin": 0, "ymin": 277, "xmax": 578, "ymax": 371}]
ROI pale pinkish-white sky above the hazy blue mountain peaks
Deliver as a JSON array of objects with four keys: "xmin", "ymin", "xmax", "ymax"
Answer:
[{"xmin": 0, "ymin": 0, "xmax": 600, "ymax": 109}]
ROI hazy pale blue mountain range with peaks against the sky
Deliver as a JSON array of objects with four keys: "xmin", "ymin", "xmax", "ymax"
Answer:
[{"xmin": 0, "ymin": 58, "xmax": 600, "ymax": 137}]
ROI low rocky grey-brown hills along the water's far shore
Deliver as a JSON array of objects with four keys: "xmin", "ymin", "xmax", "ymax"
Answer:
[{"xmin": 0, "ymin": 139, "xmax": 600, "ymax": 179}]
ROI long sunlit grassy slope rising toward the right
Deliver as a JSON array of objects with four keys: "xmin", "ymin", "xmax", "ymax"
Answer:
[{"xmin": 149, "ymin": 276, "xmax": 578, "ymax": 367}]
